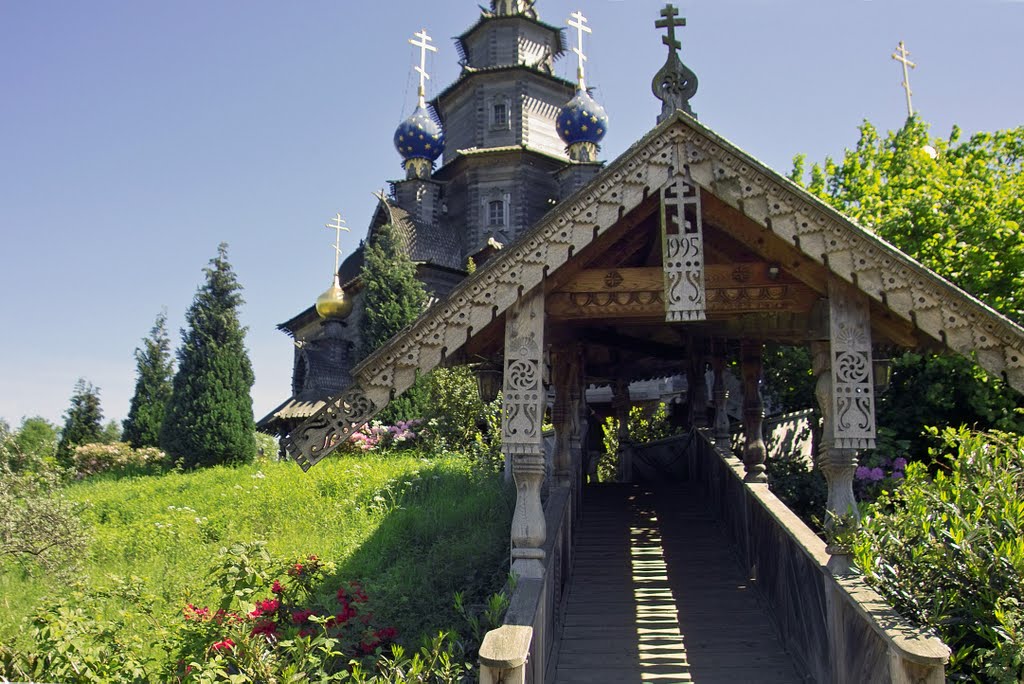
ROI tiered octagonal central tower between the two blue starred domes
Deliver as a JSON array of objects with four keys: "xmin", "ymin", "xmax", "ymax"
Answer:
[{"xmin": 432, "ymin": 0, "xmax": 574, "ymax": 253}]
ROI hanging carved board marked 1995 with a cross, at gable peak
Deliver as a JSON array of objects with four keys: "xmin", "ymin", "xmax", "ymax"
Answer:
[{"xmin": 662, "ymin": 176, "xmax": 708, "ymax": 323}]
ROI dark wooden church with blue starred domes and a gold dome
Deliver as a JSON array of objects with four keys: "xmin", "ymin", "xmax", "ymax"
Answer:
[{"xmin": 257, "ymin": 0, "xmax": 607, "ymax": 434}]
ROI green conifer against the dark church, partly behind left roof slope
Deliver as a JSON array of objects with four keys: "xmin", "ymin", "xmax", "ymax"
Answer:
[{"xmin": 359, "ymin": 224, "xmax": 429, "ymax": 423}]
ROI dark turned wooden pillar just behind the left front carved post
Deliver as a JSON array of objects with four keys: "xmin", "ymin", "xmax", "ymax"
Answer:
[{"xmin": 551, "ymin": 344, "xmax": 583, "ymax": 486}]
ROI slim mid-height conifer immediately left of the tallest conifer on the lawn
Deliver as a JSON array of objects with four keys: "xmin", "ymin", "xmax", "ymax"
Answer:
[{"xmin": 122, "ymin": 311, "xmax": 174, "ymax": 448}]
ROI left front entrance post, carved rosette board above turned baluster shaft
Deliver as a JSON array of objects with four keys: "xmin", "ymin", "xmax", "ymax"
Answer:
[{"xmin": 502, "ymin": 285, "xmax": 547, "ymax": 578}]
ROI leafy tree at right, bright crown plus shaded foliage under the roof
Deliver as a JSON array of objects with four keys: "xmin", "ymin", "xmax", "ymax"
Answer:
[{"xmin": 790, "ymin": 117, "xmax": 1024, "ymax": 457}]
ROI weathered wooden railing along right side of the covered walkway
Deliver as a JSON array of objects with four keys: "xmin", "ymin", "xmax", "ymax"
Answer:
[{"xmin": 687, "ymin": 431, "xmax": 949, "ymax": 684}]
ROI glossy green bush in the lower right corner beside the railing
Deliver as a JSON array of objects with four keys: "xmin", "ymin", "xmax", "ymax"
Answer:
[{"xmin": 854, "ymin": 428, "xmax": 1024, "ymax": 684}]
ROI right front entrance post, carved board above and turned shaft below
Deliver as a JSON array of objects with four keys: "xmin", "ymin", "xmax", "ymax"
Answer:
[{"xmin": 811, "ymin": 279, "xmax": 874, "ymax": 572}]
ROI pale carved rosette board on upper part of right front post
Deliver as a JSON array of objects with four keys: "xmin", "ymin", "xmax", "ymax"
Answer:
[{"xmin": 828, "ymin": 279, "xmax": 874, "ymax": 448}]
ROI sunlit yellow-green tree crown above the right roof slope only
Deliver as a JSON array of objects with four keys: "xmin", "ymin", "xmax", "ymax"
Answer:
[{"xmin": 791, "ymin": 117, "xmax": 1024, "ymax": 322}]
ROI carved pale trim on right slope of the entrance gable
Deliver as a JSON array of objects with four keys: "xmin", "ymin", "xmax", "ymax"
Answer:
[{"xmin": 675, "ymin": 116, "xmax": 1024, "ymax": 392}]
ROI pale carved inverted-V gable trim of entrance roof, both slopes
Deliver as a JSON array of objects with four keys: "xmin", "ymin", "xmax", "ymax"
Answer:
[{"xmin": 284, "ymin": 112, "xmax": 1024, "ymax": 462}]
